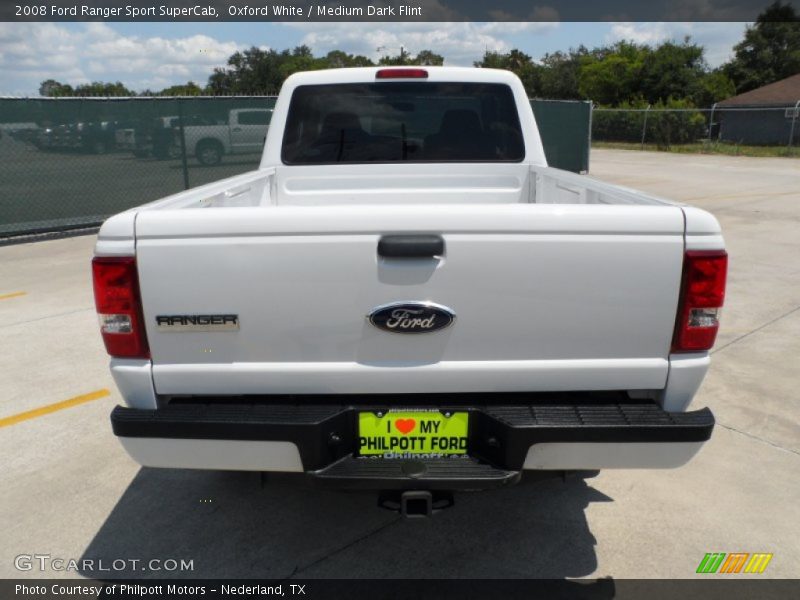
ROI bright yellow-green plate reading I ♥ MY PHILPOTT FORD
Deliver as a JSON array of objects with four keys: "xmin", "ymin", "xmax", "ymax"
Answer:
[{"xmin": 358, "ymin": 409, "xmax": 469, "ymax": 458}]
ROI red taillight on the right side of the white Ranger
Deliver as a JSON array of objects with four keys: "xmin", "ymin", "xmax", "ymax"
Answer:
[{"xmin": 672, "ymin": 250, "xmax": 728, "ymax": 352}]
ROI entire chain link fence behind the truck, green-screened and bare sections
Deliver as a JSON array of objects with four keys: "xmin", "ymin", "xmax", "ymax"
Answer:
[{"xmin": 0, "ymin": 96, "xmax": 800, "ymax": 238}]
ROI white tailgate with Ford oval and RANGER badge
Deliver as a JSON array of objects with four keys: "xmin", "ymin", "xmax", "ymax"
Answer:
[{"xmin": 136, "ymin": 204, "xmax": 684, "ymax": 395}]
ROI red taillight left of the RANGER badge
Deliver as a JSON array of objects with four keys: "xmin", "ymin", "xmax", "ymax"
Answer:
[{"xmin": 92, "ymin": 256, "xmax": 150, "ymax": 358}]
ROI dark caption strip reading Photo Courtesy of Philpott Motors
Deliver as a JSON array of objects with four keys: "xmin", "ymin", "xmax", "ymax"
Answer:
[{"xmin": 0, "ymin": 575, "xmax": 800, "ymax": 600}]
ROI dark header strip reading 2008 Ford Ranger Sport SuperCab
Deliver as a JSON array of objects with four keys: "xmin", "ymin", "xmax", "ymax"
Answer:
[{"xmin": 0, "ymin": 0, "xmax": 800, "ymax": 22}]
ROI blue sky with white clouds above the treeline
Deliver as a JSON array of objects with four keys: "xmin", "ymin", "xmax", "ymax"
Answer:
[{"xmin": 0, "ymin": 22, "xmax": 746, "ymax": 96}]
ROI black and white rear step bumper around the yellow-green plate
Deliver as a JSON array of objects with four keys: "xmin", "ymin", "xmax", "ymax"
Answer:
[{"xmin": 111, "ymin": 394, "xmax": 714, "ymax": 489}]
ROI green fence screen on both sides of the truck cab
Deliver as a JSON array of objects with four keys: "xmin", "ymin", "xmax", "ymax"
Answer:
[{"xmin": 0, "ymin": 96, "xmax": 591, "ymax": 238}]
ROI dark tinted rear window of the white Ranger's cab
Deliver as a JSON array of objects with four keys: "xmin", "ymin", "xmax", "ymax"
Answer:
[{"xmin": 281, "ymin": 82, "xmax": 525, "ymax": 165}]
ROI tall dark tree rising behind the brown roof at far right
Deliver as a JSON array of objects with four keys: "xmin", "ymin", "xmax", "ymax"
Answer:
[{"xmin": 723, "ymin": 2, "xmax": 800, "ymax": 94}]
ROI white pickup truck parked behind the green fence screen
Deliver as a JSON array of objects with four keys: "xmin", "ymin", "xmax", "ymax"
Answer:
[{"xmin": 180, "ymin": 108, "xmax": 272, "ymax": 166}]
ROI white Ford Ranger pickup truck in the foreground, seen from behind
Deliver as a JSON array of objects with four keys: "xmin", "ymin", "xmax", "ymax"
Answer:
[{"xmin": 93, "ymin": 67, "xmax": 727, "ymax": 514}]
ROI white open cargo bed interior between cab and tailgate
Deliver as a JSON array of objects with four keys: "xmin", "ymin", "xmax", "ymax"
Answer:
[{"xmin": 122, "ymin": 164, "xmax": 677, "ymax": 211}]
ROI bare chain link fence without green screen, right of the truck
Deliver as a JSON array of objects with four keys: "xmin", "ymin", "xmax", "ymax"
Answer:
[{"xmin": 592, "ymin": 101, "xmax": 800, "ymax": 149}]
